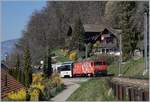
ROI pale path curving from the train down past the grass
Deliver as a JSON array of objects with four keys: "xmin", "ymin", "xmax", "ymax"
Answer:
[{"xmin": 51, "ymin": 78, "xmax": 88, "ymax": 102}]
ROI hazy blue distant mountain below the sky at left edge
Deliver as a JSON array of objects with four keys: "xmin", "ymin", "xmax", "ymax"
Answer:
[{"xmin": 1, "ymin": 39, "xmax": 19, "ymax": 59}]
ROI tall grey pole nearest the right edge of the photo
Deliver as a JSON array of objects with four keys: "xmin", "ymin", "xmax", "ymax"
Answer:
[{"xmin": 143, "ymin": 12, "xmax": 148, "ymax": 75}]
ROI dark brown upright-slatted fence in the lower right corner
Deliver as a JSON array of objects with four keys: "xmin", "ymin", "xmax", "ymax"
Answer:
[{"xmin": 108, "ymin": 81, "xmax": 149, "ymax": 101}]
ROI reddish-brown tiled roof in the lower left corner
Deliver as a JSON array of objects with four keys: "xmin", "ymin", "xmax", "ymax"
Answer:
[{"xmin": 1, "ymin": 64, "xmax": 25, "ymax": 99}]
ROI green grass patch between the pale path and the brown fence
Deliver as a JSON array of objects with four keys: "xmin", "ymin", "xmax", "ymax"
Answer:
[{"xmin": 68, "ymin": 78, "xmax": 114, "ymax": 101}]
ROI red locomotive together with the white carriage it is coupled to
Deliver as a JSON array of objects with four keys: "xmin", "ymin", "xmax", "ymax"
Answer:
[{"xmin": 58, "ymin": 60, "xmax": 108, "ymax": 77}]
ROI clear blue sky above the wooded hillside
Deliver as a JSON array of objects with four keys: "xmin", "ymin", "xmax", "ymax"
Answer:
[{"xmin": 1, "ymin": 0, "xmax": 46, "ymax": 41}]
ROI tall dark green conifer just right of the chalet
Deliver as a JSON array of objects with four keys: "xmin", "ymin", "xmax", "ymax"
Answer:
[{"xmin": 120, "ymin": 1, "xmax": 138, "ymax": 60}]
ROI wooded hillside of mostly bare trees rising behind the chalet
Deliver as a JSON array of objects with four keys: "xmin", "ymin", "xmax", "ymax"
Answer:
[{"xmin": 8, "ymin": 1, "xmax": 148, "ymax": 64}]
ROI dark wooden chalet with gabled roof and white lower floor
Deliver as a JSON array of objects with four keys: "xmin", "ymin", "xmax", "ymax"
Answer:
[{"xmin": 67, "ymin": 24, "xmax": 119, "ymax": 54}]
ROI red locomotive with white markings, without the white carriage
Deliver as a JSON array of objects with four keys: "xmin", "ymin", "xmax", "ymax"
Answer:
[{"xmin": 73, "ymin": 61, "xmax": 108, "ymax": 76}]
